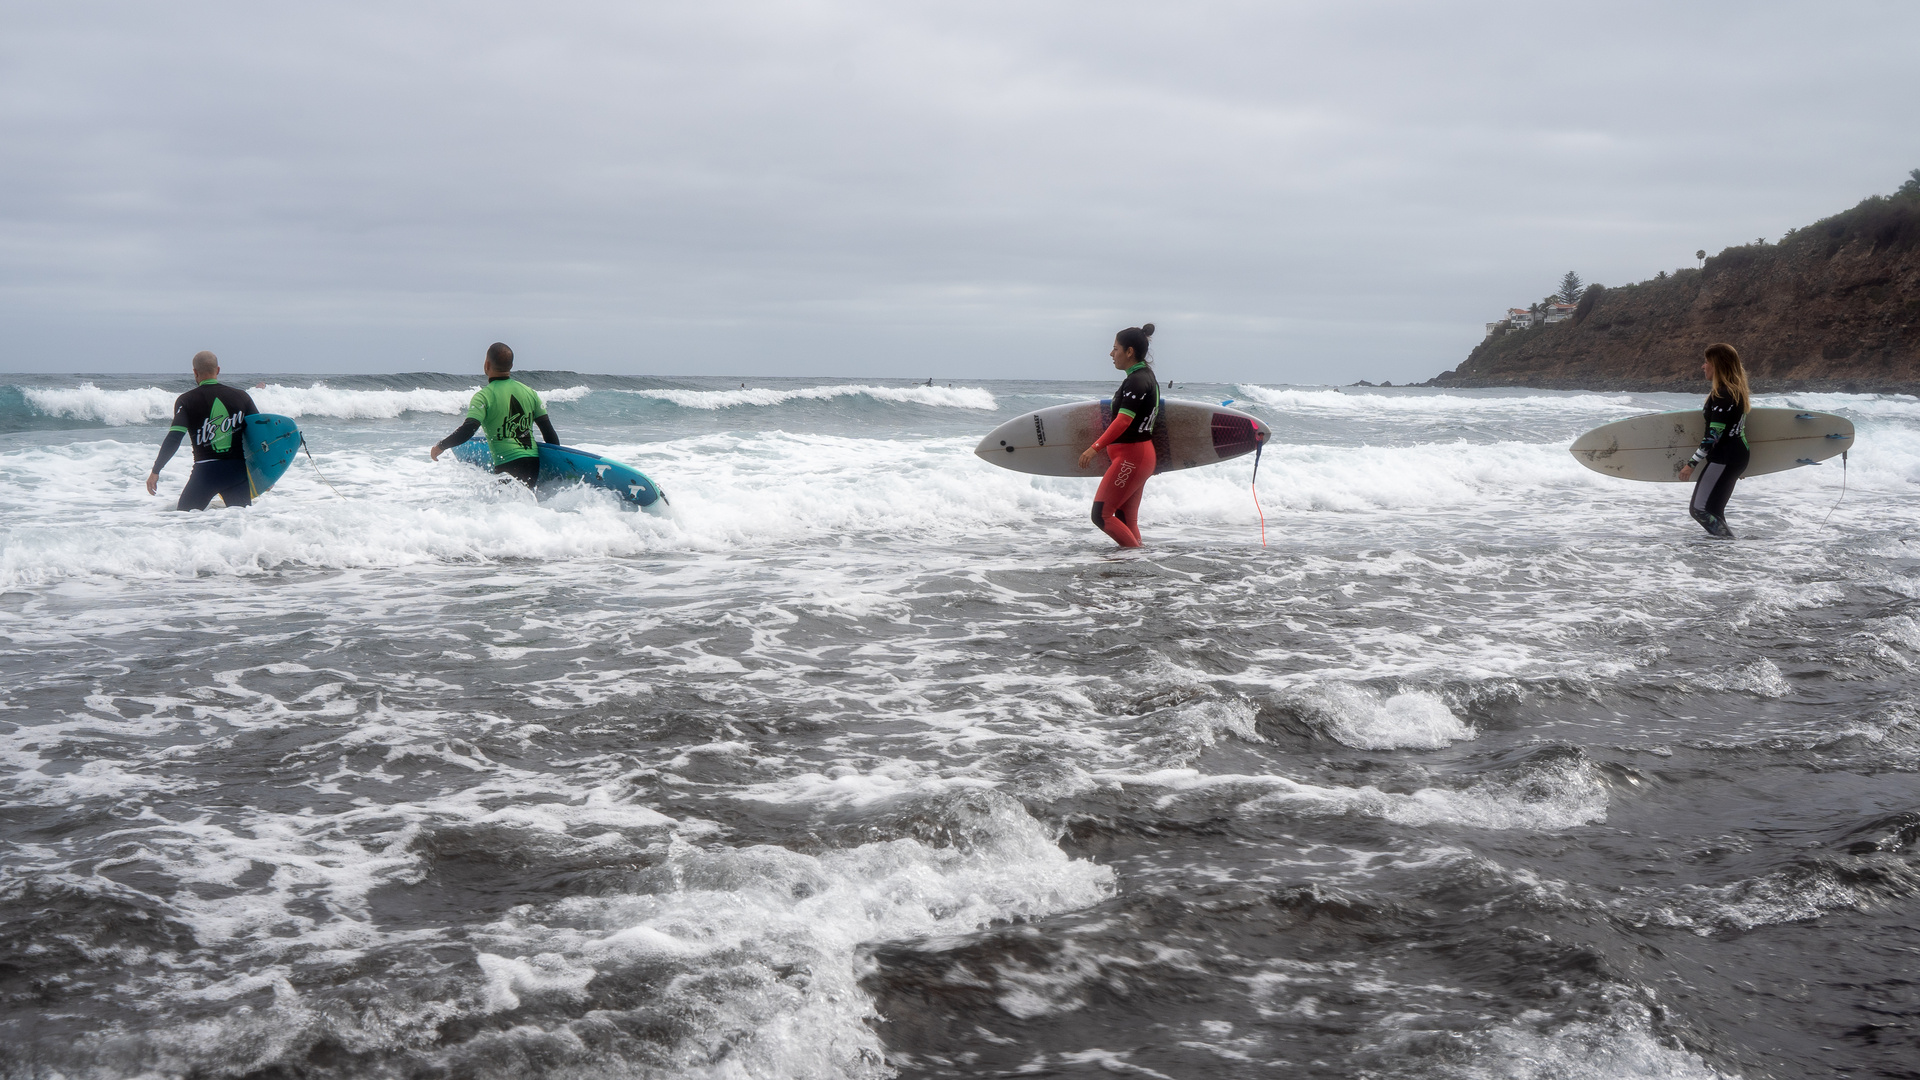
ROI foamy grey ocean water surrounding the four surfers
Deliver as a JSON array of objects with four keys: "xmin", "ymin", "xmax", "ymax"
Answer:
[{"xmin": 0, "ymin": 373, "xmax": 1920, "ymax": 1080}]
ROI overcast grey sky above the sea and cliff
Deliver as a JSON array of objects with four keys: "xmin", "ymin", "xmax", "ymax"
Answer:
[{"xmin": 0, "ymin": 0, "xmax": 1920, "ymax": 382}]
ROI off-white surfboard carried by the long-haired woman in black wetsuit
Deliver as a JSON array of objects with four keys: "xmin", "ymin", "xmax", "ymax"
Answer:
[{"xmin": 1571, "ymin": 409, "xmax": 1853, "ymax": 482}]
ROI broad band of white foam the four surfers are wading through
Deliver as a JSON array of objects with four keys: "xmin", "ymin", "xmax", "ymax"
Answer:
[{"xmin": 15, "ymin": 382, "xmax": 1920, "ymax": 588}]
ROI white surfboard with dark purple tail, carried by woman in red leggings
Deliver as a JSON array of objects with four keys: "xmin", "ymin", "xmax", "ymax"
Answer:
[{"xmin": 973, "ymin": 398, "xmax": 1271, "ymax": 477}]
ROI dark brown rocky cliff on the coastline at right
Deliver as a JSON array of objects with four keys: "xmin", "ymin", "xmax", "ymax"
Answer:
[{"xmin": 1427, "ymin": 169, "xmax": 1920, "ymax": 394}]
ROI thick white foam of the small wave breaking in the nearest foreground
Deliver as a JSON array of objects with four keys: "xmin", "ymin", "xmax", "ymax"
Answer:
[{"xmin": 460, "ymin": 792, "xmax": 1114, "ymax": 1076}]
